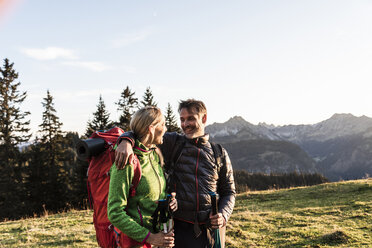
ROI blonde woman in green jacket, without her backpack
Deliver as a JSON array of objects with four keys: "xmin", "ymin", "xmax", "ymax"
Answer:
[{"xmin": 107, "ymin": 106, "xmax": 176, "ymax": 247}]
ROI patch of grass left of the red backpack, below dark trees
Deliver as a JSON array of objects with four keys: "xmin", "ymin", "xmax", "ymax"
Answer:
[{"xmin": 0, "ymin": 210, "xmax": 98, "ymax": 247}]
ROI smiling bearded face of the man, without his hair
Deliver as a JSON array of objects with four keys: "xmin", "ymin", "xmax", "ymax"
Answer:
[{"xmin": 180, "ymin": 108, "xmax": 207, "ymax": 139}]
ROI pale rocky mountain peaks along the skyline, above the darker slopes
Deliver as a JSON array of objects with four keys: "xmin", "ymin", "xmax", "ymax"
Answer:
[{"xmin": 206, "ymin": 114, "xmax": 372, "ymax": 144}]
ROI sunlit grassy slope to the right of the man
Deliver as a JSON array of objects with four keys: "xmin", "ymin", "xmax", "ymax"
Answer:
[{"xmin": 227, "ymin": 180, "xmax": 372, "ymax": 247}]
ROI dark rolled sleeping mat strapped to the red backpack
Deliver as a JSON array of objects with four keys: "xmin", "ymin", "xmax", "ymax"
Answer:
[{"xmin": 76, "ymin": 138, "xmax": 105, "ymax": 161}]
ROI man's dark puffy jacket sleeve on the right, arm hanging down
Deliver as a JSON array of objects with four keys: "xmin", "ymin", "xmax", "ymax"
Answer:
[{"xmin": 217, "ymin": 149, "xmax": 236, "ymax": 222}]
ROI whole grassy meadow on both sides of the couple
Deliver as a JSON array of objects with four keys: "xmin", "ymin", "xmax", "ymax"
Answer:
[{"xmin": 0, "ymin": 179, "xmax": 372, "ymax": 248}]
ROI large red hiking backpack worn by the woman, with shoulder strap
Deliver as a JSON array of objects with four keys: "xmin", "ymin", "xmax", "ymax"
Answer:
[{"xmin": 88, "ymin": 127, "xmax": 147, "ymax": 248}]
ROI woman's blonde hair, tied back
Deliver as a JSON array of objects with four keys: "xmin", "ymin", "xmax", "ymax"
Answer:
[{"xmin": 129, "ymin": 106, "xmax": 162, "ymax": 140}]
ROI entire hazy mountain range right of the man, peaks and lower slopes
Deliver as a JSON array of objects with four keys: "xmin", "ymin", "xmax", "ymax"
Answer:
[{"xmin": 206, "ymin": 114, "xmax": 372, "ymax": 181}]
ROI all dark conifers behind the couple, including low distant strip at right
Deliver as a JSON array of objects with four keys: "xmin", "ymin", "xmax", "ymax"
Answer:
[{"xmin": 0, "ymin": 59, "xmax": 324, "ymax": 220}]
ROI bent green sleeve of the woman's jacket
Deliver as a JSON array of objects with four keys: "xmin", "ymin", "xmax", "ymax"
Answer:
[{"xmin": 107, "ymin": 164, "xmax": 150, "ymax": 242}]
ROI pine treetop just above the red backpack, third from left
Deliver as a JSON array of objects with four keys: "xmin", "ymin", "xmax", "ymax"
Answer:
[{"xmin": 85, "ymin": 95, "xmax": 113, "ymax": 137}]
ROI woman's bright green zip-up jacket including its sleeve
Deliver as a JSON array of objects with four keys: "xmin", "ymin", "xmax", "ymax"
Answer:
[{"xmin": 107, "ymin": 140, "xmax": 166, "ymax": 242}]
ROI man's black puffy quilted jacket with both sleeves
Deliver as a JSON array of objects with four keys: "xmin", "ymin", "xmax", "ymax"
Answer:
[{"xmin": 159, "ymin": 133, "xmax": 235, "ymax": 223}]
